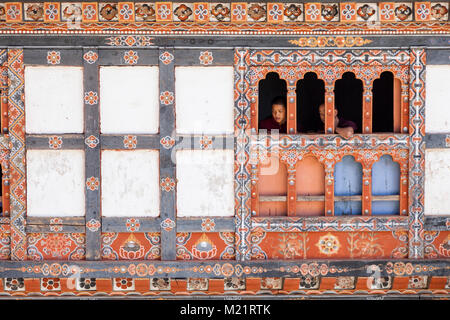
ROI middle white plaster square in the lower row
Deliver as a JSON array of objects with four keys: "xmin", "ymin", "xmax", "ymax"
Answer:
[{"xmin": 101, "ymin": 150, "xmax": 159, "ymax": 217}]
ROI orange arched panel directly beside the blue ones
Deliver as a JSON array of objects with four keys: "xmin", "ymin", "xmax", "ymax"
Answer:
[{"xmin": 295, "ymin": 157, "xmax": 325, "ymax": 216}]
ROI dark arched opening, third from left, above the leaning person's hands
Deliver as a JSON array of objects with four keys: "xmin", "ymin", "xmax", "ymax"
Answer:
[{"xmin": 334, "ymin": 72, "xmax": 363, "ymax": 133}]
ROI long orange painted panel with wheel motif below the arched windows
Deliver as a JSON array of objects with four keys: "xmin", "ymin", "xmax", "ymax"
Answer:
[{"xmin": 252, "ymin": 231, "xmax": 408, "ymax": 260}]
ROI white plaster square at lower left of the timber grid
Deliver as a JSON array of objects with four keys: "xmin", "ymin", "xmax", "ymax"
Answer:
[{"xmin": 26, "ymin": 150, "xmax": 86, "ymax": 217}]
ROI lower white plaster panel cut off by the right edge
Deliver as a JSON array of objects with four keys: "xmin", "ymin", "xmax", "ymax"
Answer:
[{"xmin": 425, "ymin": 149, "xmax": 450, "ymax": 215}]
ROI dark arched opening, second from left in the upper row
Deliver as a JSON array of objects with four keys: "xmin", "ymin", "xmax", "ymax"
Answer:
[{"xmin": 296, "ymin": 72, "xmax": 325, "ymax": 133}]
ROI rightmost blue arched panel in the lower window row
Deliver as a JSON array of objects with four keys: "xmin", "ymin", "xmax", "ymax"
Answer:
[{"xmin": 372, "ymin": 155, "xmax": 400, "ymax": 215}]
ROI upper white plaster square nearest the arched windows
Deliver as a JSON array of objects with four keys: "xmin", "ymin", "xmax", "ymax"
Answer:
[{"xmin": 175, "ymin": 67, "xmax": 234, "ymax": 134}]
